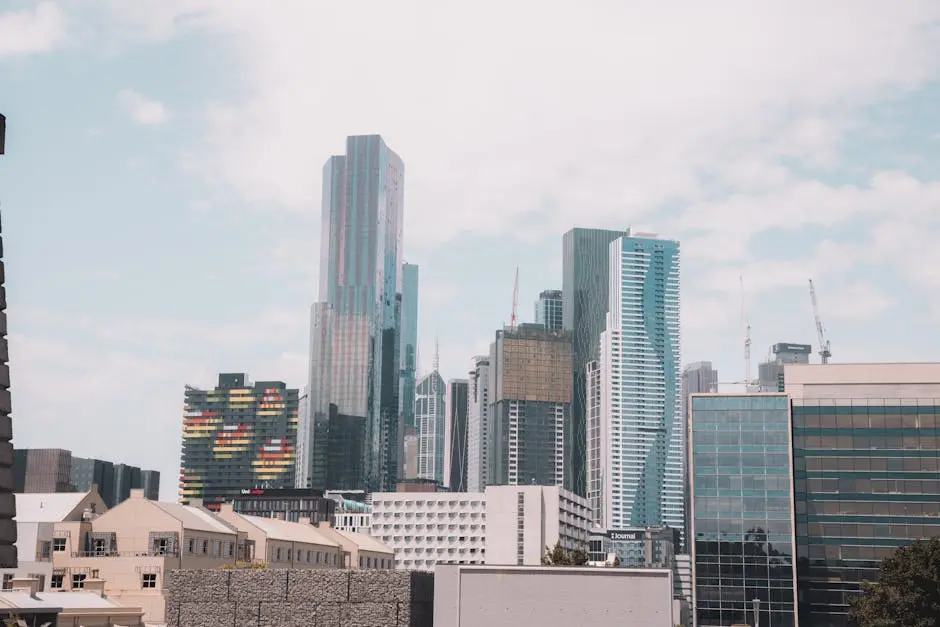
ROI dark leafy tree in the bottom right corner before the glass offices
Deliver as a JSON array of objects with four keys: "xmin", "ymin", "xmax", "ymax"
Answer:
[{"xmin": 849, "ymin": 537, "xmax": 940, "ymax": 627}]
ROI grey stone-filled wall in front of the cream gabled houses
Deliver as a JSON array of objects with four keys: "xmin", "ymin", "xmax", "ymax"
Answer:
[{"xmin": 165, "ymin": 569, "xmax": 434, "ymax": 627}]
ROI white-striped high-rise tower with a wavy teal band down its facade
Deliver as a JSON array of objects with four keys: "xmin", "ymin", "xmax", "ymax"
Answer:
[{"xmin": 586, "ymin": 233, "xmax": 685, "ymax": 535}]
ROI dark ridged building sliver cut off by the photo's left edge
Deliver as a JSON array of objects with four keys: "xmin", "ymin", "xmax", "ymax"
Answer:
[{"xmin": 0, "ymin": 113, "xmax": 16, "ymax": 568}]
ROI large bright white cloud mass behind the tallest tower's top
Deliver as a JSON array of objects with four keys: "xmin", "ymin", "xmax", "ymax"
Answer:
[{"xmin": 84, "ymin": 0, "xmax": 940, "ymax": 245}]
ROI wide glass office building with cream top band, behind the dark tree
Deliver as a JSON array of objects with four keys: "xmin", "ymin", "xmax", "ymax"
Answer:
[{"xmin": 784, "ymin": 363, "xmax": 940, "ymax": 627}]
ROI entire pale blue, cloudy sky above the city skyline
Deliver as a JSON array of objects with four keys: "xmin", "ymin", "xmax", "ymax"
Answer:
[{"xmin": 0, "ymin": 0, "xmax": 940, "ymax": 500}]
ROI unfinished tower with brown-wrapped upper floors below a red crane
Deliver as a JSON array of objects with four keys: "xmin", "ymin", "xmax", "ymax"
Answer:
[{"xmin": 486, "ymin": 324, "xmax": 572, "ymax": 486}]
